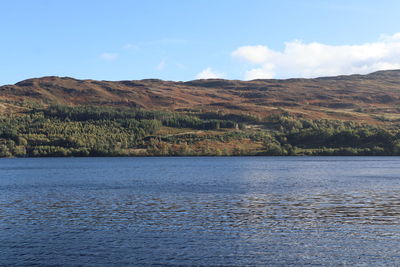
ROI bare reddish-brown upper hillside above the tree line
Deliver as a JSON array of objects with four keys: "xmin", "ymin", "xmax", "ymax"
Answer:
[{"xmin": 0, "ymin": 70, "xmax": 400, "ymax": 124}]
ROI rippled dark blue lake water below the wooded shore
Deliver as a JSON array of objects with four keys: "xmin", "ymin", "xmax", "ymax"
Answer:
[{"xmin": 0, "ymin": 157, "xmax": 400, "ymax": 266}]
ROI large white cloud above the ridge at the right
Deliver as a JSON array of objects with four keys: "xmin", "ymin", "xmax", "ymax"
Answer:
[{"xmin": 232, "ymin": 33, "xmax": 400, "ymax": 79}]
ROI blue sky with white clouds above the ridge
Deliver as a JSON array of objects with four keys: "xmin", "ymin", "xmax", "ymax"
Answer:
[{"xmin": 0, "ymin": 0, "xmax": 400, "ymax": 84}]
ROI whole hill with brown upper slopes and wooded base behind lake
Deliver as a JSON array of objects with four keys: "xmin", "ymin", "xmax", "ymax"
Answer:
[{"xmin": 0, "ymin": 70, "xmax": 400, "ymax": 157}]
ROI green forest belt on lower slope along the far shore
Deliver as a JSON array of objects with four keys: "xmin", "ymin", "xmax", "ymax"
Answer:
[{"xmin": 0, "ymin": 105, "xmax": 400, "ymax": 157}]
